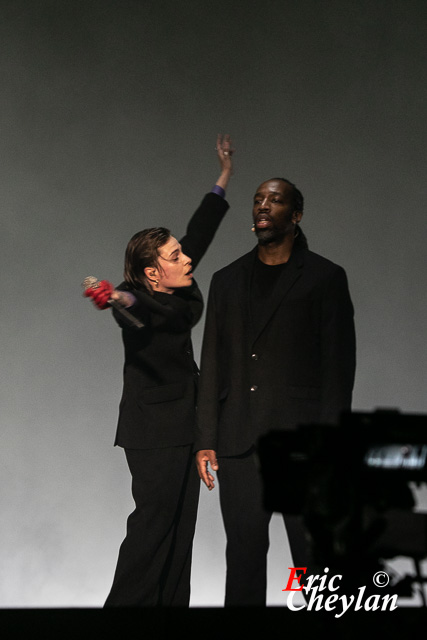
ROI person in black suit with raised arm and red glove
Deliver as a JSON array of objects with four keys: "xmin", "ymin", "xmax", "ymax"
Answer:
[{"xmin": 85, "ymin": 136, "xmax": 233, "ymax": 607}]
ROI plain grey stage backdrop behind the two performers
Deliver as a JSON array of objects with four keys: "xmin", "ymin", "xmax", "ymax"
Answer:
[{"xmin": 0, "ymin": 0, "xmax": 427, "ymax": 607}]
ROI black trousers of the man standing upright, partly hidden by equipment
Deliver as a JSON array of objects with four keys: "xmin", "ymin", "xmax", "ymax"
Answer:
[{"xmin": 218, "ymin": 451, "xmax": 310, "ymax": 607}]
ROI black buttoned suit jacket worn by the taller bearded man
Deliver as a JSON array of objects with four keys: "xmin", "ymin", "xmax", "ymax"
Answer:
[{"xmin": 195, "ymin": 242, "xmax": 355, "ymax": 456}]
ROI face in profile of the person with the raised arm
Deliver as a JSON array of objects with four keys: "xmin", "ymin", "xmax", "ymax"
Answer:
[{"xmin": 145, "ymin": 236, "xmax": 193, "ymax": 293}]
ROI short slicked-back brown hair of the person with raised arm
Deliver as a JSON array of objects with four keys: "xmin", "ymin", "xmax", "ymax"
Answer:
[{"xmin": 124, "ymin": 227, "xmax": 171, "ymax": 292}]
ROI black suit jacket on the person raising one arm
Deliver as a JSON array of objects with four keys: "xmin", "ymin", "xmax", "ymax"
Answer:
[{"xmin": 113, "ymin": 193, "xmax": 228, "ymax": 449}]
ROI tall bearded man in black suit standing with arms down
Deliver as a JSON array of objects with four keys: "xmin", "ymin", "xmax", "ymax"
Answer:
[{"xmin": 196, "ymin": 178, "xmax": 355, "ymax": 606}]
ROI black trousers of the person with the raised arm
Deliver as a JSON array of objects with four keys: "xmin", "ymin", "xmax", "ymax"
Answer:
[{"xmin": 105, "ymin": 445, "xmax": 200, "ymax": 607}]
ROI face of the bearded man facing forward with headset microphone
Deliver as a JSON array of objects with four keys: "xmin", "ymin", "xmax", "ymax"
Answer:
[{"xmin": 252, "ymin": 180, "xmax": 301, "ymax": 244}]
